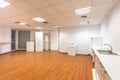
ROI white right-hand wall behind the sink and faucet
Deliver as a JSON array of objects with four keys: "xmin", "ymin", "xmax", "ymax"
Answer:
[{"xmin": 101, "ymin": 0, "xmax": 120, "ymax": 52}]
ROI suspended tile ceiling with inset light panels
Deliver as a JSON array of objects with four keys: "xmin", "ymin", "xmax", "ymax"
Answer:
[{"xmin": 0, "ymin": 0, "xmax": 117, "ymax": 29}]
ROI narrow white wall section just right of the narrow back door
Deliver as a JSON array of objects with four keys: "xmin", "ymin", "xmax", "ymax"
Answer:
[{"xmin": 50, "ymin": 30, "xmax": 59, "ymax": 50}]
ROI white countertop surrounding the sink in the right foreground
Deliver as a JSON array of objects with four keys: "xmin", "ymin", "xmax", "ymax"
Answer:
[{"xmin": 93, "ymin": 49, "xmax": 120, "ymax": 80}]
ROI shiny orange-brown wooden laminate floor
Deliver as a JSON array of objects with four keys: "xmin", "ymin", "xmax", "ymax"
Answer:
[{"xmin": 0, "ymin": 51, "xmax": 93, "ymax": 80}]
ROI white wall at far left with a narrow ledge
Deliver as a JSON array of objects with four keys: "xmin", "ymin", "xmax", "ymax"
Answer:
[{"xmin": 0, "ymin": 27, "xmax": 11, "ymax": 54}]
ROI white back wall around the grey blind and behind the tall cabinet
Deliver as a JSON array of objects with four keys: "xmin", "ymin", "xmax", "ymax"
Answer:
[{"xmin": 16, "ymin": 30, "xmax": 59, "ymax": 50}]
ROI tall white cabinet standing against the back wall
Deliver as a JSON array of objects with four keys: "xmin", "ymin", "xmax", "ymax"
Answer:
[{"xmin": 35, "ymin": 31, "xmax": 43, "ymax": 52}]
